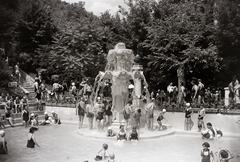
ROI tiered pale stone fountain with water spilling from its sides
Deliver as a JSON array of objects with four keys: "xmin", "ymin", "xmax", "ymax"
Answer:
[{"xmin": 91, "ymin": 43, "xmax": 149, "ymax": 121}]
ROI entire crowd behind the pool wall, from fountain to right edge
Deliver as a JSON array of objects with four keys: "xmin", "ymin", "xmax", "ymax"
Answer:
[{"xmin": 150, "ymin": 76, "xmax": 240, "ymax": 109}]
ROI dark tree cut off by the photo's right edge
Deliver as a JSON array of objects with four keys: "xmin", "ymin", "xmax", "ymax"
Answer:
[{"xmin": 215, "ymin": 0, "xmax": 240, "ymax": 85}]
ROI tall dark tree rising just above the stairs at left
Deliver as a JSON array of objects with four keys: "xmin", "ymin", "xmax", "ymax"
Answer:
[{"xmin": 17, "ymin": 0, "xmax": 57, "ymax": 72}]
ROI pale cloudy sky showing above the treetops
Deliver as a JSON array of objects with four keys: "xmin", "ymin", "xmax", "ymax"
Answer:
[{"xmin": 62, "ymin": 0, "xmax": 128, "ymax": 15}]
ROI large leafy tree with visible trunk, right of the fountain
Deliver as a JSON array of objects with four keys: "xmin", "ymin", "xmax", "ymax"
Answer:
[{"xmin": 144, "ymin": 0, "xmax": 221, "ymax": 101}]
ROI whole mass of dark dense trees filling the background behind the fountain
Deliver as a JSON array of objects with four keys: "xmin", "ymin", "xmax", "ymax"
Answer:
[{"xmin": 0, "ymin": 0, "xmax": 240, "ymax": 89}]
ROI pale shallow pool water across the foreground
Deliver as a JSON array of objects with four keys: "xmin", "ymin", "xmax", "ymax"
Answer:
[{"xmin": 0, "ymin": 124, "xmax": 240, "ymax": 162}]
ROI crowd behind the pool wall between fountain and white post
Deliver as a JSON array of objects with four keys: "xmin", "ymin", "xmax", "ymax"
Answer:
[{"xmin": 151, "ymin": 79, "xmax": 224, "ymax": 109}]
